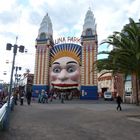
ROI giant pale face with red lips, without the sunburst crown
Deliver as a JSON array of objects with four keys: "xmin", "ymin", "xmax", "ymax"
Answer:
[{"xmin": 50, "ymin": 57, "xmax": 80, "ymax": 89}]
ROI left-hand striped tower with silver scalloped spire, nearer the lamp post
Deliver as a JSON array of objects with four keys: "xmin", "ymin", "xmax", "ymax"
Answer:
[{"xmin": 33, "ymin": 14, "xmax": 53, "ymax": 92}]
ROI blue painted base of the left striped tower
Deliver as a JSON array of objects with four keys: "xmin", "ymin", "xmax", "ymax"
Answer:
[{"xmin": 32, "ymin": 85, "xmax": 49, "ymax": 97}]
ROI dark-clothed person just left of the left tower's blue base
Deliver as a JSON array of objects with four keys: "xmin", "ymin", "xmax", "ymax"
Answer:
[{"xmin": 26, "ymin": 85, "xmax": 32, "ymax": 105}]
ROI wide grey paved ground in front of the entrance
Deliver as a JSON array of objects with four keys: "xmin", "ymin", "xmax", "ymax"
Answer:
[{"xmin": 0, "ymin": 101, "xmax": 140, "ymax": 140}]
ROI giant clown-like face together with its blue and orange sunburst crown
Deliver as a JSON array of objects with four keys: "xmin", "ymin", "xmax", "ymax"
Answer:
[{"xmin": 50, "ymin": 43, "xmax": 81, "ymax": 96}]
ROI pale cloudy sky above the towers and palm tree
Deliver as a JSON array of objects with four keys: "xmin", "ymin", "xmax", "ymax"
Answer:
[{"xmin": 0, "ymin": 0, "xmax": 140, "ymax": 81}]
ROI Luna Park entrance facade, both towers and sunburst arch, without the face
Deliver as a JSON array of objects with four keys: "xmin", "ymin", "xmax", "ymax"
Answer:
[{"xmin": 33, "ymin": 9, "xmax": 98, "ymax": 99}]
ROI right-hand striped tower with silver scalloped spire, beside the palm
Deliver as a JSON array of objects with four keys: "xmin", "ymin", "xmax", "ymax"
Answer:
[{"xmin": 81, "ymin": 9, "xmax": 98, "ymax": 98}]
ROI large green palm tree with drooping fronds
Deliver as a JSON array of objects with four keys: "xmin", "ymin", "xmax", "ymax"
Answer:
[{"xmin": 96, "ymin": 18, "xmax": 140, "ymax": 105}]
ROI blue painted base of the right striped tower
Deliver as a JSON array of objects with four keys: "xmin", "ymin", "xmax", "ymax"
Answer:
[{"xmin": 80, "ymin": 86, "xmax": 98, "ymax": 100}]
